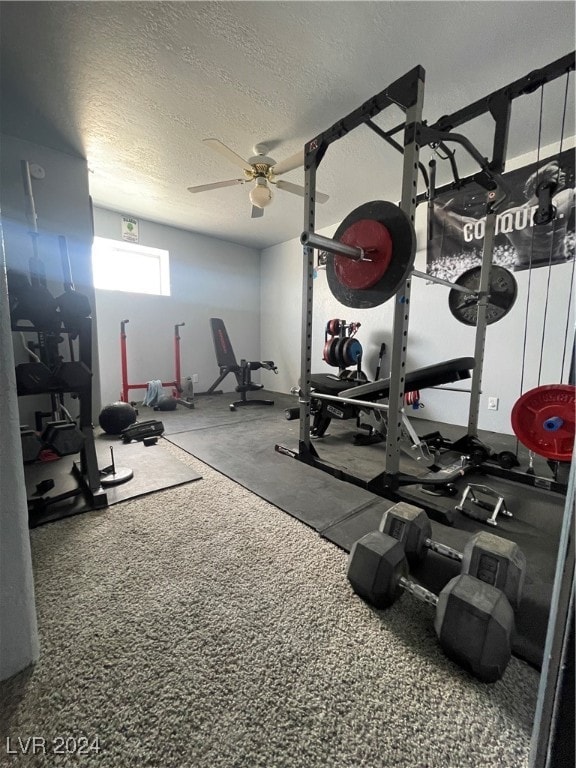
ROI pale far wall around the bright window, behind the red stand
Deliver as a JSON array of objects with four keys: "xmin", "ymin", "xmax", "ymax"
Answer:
[{"xmin": 94, "ymin": 207, "xmax": 276, "ymax": 405}]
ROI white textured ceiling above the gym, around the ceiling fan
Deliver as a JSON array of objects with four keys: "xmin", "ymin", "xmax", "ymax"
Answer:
[{"xmin": 0, "ymin": 0, "xmax": 574, "ymax": 247}]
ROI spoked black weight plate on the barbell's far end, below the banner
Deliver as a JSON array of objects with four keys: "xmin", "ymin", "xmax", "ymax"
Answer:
[{"xmin": 448, "ymin": 264, "xmax": 518, "ymax": 325}]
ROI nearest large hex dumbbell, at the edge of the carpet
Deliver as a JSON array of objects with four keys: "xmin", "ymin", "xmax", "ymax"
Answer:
[{"xmin": 347, "ymin": 531, "xmax": 514, "ymax": 683}]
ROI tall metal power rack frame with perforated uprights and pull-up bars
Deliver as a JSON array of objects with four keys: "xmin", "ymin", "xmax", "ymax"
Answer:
[{"xmin": 277, "ymin": 53, "xmax": 574, "ymax": 495}]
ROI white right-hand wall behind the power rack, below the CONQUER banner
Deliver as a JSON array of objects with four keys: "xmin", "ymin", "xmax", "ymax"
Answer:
[{"xmin": 261, "ymin": 140, "xmax": 575, "ymax": 434}]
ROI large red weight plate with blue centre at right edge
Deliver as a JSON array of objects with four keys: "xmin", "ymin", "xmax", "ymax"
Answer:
[{"xmin": 511, "ymin": 384, "xmax": 576, "ymax": 461}]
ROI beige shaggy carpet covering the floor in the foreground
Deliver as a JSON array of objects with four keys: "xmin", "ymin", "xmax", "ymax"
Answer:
[{"xmin": 0, "ymin": 441, "xmax": 538, "ymax": 768}]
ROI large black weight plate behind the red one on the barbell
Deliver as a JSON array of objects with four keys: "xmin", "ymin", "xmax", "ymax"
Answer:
[{"xmin": 326, "ymin": 200, "xmax": 416, "ymax": 309}]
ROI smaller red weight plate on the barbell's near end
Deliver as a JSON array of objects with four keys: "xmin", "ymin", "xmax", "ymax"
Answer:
[{"xmin": 334, "ymin": 219, "xmax": 392, "ymax": 291}]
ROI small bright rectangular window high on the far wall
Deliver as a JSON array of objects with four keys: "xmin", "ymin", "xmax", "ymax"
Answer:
[{"xmin": 92, "ymin": 237, "xmax": 170, "ymax": 296}]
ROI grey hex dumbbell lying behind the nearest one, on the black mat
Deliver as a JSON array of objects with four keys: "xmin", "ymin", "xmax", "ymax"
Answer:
[{"xmin": 379, "ymin": 501, "xmax": 526, "ymax": 609}]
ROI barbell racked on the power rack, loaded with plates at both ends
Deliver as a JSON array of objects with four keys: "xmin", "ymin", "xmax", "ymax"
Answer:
[{"xmin": 300, "ymin": 200, "xmax": 517, "ymax": 325}]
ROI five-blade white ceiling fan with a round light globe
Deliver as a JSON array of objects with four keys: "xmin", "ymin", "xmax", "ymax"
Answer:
[{"xmin": 188, "ymin": 139, "xmax": 328, "ymax": 219}]
